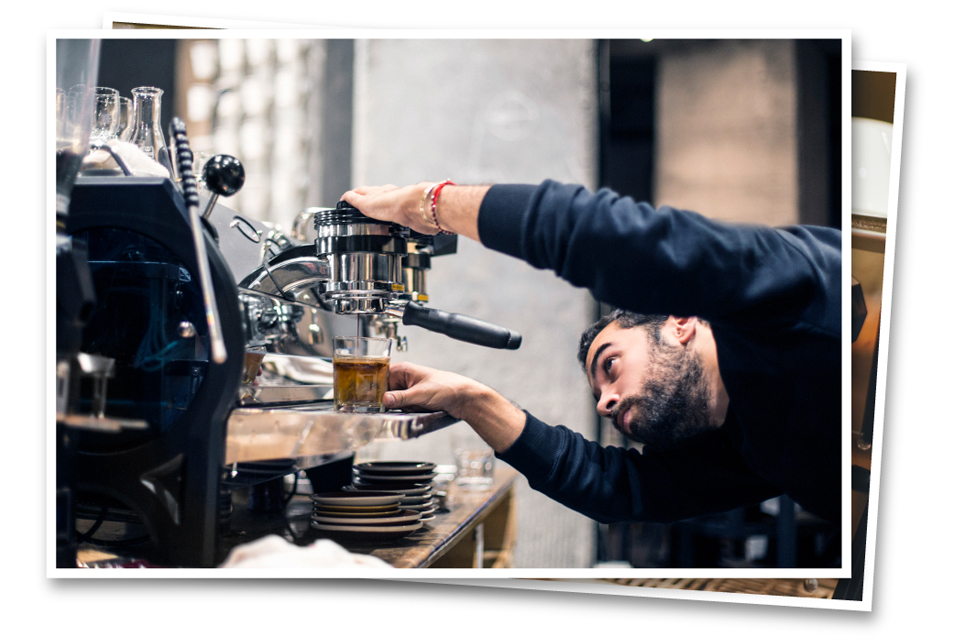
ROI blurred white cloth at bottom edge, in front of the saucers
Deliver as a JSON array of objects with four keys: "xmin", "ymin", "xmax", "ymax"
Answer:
[{"xmin": 220, "ymin": 535, "xmax": 393, "ymax": 568}]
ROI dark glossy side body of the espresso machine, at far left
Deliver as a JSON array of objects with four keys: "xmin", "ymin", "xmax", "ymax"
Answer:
[{"xmin": 67, "ymin": 177, "xmax": 244, "ymax": 567}]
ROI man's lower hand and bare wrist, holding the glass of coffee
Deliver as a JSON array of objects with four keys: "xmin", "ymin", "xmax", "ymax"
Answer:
[{"xmin": 383, "ymin": 362, "xmax": 527, "ymax": 453}]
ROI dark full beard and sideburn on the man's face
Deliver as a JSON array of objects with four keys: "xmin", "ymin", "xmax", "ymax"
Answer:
[{"xmin": 612, "ymin": 337, "xmax": 715, "ymax": 450}]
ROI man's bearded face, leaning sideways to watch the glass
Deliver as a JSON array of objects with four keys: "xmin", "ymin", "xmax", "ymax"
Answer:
[{"xmin": 586, "ymin": 322, "xmax": 711, "ymax": 450}]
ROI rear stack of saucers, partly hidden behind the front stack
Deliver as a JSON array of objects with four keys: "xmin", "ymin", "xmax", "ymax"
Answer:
[{"xmin": 345, "ymin": 461, "xmax": 437, "ymax": 522}]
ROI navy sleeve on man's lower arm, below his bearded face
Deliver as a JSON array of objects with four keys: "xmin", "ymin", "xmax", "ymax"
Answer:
[{"xmin": 498, "ymin": 413, "xmax": 783, "ymax": 523}]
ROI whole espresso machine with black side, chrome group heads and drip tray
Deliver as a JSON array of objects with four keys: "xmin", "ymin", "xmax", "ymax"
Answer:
[{"xmin": 57, "ymin": 101, "xmax": 520, "ymax": 567}]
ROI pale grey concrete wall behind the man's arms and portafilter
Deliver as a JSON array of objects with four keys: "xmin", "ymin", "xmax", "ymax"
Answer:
[{"xmin": 353, "ymin": 40, "xmax": 598, "ymax": 568}]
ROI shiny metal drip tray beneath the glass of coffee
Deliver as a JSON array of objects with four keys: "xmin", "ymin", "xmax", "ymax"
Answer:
[{"xmin": 224, "ymin": 401, "xmax": 459, "ymax": 465}]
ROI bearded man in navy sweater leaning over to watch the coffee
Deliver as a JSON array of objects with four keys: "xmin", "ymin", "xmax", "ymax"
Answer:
[{"xmin": 342, "ymin": 180, "xmax": 843, "ymax": 525}]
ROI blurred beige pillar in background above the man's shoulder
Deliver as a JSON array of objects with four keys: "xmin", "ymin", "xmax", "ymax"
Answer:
[{"xmin": 654, "ymin": 40, "xmax": 800, "ymax": 225}]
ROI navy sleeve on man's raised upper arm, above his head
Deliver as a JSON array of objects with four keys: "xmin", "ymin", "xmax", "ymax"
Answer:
[{"xmin": 478, "ymin": 181, "xmax": 841, "ymax": 333}]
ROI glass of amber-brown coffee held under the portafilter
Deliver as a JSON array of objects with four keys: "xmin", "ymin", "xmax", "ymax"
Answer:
[{"xmin": 333, "ymin": 337, "xmax": 393, "ymax": 412}]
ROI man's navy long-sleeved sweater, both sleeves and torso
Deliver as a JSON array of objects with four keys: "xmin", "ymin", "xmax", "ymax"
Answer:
[{"xmin": 478, "ymin": 181, "xmax": 843, "ymax": 524}]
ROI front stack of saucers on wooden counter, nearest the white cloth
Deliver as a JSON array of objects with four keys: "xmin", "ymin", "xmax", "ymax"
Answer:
[{"xmin": 310, "ymin": 490, "xmax": 422, "ymax": 540}]
